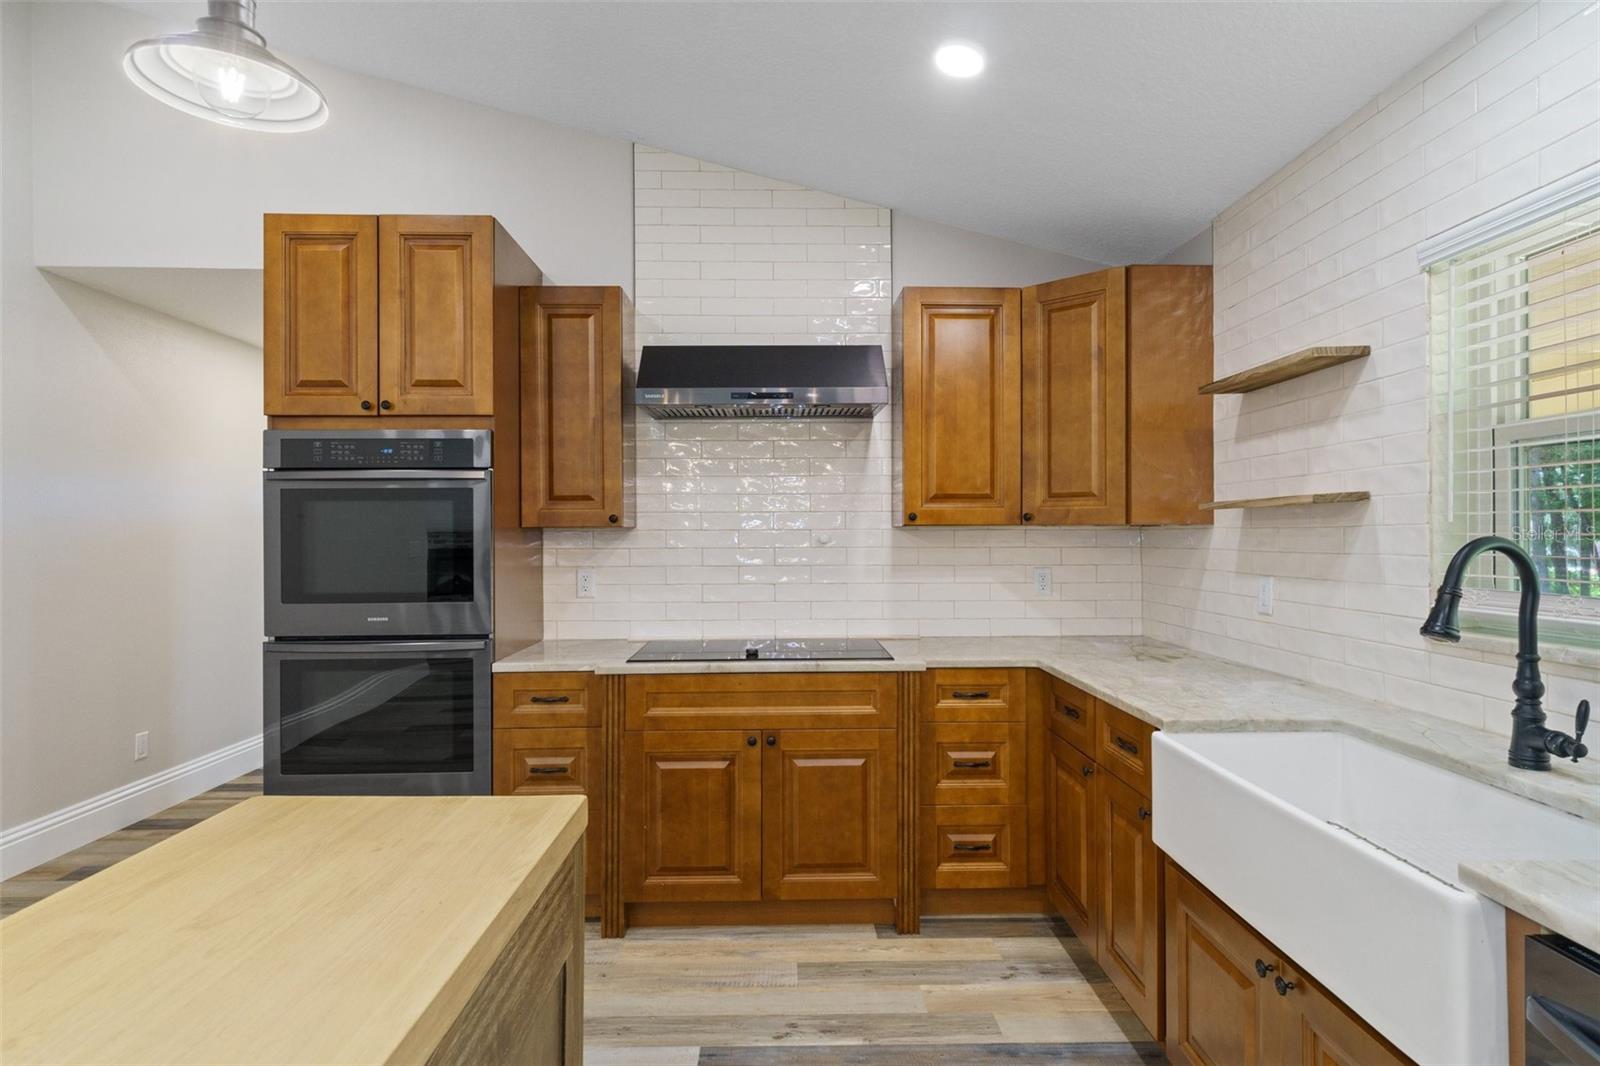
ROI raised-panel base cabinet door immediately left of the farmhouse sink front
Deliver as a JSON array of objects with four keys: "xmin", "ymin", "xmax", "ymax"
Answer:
[{"xmin": 1094, "ymin": 773, "xmax": 1163, "ymax": 1039}]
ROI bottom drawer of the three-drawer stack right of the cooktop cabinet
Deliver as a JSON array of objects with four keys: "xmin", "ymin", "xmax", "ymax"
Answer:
[{"xmin": 922, "ymin": 805, "xmax": 1027, "ymax": 888}]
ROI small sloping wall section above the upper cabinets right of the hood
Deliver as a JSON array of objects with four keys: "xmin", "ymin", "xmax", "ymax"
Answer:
[{"xmin": 894, "ymin": 211, "xmax": 1104, "ymax": 291}]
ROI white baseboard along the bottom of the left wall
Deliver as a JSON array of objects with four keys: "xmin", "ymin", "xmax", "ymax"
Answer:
[{"xmin": 0, "ymin": 735, "xmax": 261, "ymax": 879}]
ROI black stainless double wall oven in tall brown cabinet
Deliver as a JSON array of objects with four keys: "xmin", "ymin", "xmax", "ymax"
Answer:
[{"xmin": 262, "ymin": 429, "xmax": 494, "ymax": 795}]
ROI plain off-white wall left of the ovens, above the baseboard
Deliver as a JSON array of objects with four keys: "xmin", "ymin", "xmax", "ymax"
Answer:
[{"xmin": 0, "ymin": 5, "xmax": 264, "ymax": 872}]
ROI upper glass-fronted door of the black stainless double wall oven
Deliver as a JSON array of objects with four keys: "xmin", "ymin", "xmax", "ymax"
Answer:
[{"xmin": 266, "ymin": 471, "xmax": 493, "ymax": 637}]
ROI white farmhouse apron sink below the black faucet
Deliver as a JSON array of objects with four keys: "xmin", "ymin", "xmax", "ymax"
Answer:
[{"xmin": 1152, "ymin": 731, "xmax": 1600, "ymax": 1066}]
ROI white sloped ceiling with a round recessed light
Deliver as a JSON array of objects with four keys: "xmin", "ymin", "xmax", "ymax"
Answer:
[{"xmin": 128, "ymin": 0, "xmax": 1494, "ymax": 262}]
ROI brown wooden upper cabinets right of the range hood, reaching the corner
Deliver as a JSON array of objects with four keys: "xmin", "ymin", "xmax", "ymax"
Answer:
[{"xmin": 898, "ymin": 266, "xmax": 1213, "ymax": 525}]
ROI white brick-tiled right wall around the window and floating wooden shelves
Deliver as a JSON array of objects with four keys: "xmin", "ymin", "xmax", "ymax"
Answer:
[{"xmin": 1144, "ymin": 3, "xmax": 1600, "ymax": 730}]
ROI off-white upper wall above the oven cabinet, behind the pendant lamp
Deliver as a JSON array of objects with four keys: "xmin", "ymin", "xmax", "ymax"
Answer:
[{"xmin": 34, "ymin": 3, "xmax": 634, "ymax": 285}]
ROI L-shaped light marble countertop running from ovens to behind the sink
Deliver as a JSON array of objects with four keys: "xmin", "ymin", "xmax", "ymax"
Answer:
[{"xmin": 494, "ymin": 637, "xmax": 1600, "ymax": 821}]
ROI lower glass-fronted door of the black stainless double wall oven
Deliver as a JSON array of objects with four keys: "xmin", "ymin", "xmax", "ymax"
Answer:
[{"xmin": 264, "ymin": 640, "xmax": 491, "ymax": 795}]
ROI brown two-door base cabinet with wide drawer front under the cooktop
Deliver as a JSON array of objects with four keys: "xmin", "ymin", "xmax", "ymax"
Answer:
[{"xmin": 619, "ymin": 672, "xmax": 901, "ymax": 924}]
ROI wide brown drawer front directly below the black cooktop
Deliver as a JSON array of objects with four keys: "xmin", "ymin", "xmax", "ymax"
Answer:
[{"xmin": 624, "ymin": 674, "xmax": 898, "ymax": 730}]
